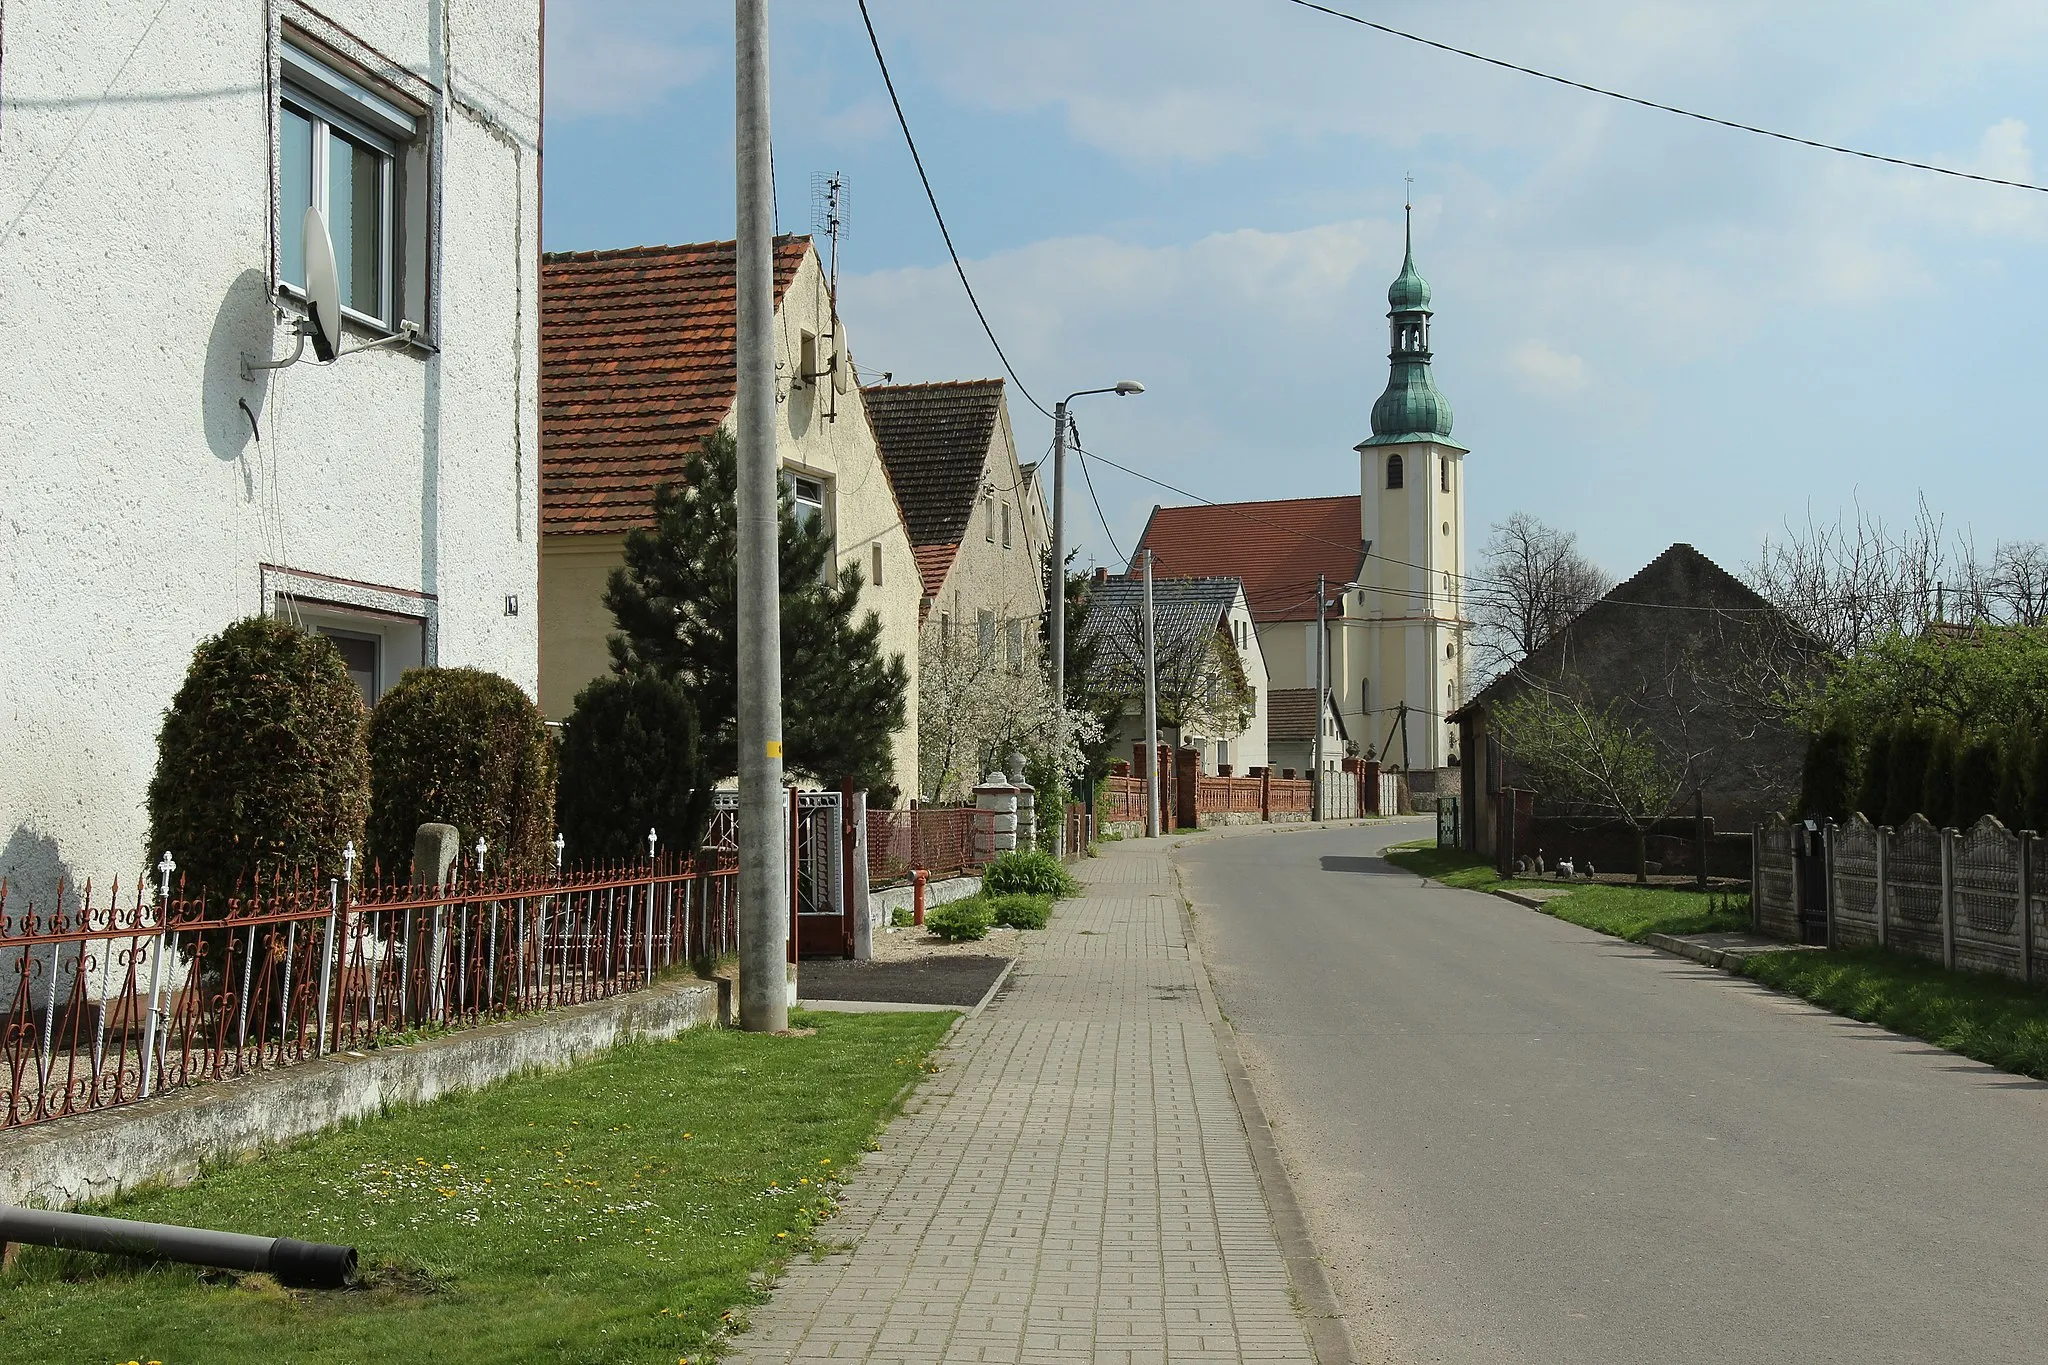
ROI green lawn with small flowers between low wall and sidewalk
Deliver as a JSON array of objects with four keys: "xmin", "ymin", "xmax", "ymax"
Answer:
[{"xmin": 0, "ymin": 1013, "xmax": 954, "ymax": 1365}]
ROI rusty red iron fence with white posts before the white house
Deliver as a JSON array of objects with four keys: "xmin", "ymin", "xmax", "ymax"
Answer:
[{"xmin": 0, "ymin": 849, "xmax": 737, "ymax": 1128}]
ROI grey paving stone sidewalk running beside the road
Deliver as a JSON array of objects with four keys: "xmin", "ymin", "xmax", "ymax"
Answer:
[{"xmin": 727, "ymin": 843, "xmax": 1315, "ymax": 1365}]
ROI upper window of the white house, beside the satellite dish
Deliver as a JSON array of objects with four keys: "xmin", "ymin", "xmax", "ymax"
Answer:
[{"xmin": 276, "ymin": 43, "xmax": 424, "ymax": 329}]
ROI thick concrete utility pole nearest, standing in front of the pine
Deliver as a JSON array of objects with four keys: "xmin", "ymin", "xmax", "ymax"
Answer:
[{"xmin": 733, "ymin": 0, "xmax": 791, "ymax": 1033}]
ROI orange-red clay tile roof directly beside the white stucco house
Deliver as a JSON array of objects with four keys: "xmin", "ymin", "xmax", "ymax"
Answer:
[{"xmin": 541, "ymin": 237, "xmax": 811, "ymax": 536}]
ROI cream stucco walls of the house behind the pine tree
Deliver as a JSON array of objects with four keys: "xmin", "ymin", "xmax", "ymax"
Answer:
[{"xmin": 541, "ymin": 250, "xmax": 922, "ymax": 796}]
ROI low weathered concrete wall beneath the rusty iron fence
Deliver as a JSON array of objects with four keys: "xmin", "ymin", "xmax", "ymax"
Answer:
[{"xmin": 0, "ymin": 980, "xmax": 731, "ymax": 1207}]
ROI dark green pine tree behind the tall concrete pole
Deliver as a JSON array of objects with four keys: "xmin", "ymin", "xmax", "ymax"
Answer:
[{"xmin": 604, "ymin": 430, "xmax": 909, "ymax": 800}]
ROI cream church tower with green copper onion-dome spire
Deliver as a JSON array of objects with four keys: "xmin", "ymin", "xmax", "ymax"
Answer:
[{"xmin": 1331, "ymin": 207, "xmax": 1466, "ymax": 769}]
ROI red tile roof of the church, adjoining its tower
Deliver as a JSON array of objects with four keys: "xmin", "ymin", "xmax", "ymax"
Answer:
[{"xmin": 1130, "ymin": 493, "xmax": 1362, "ymax": 622}]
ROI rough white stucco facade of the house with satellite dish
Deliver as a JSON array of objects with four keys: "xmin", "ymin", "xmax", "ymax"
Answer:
[{"xmin": 0, "ymin": 0, "xmax": 541, "ymax": 888}]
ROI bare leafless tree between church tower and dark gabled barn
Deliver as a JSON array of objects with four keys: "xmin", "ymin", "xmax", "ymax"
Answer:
[{"xmin": 1466, "ymin": 512, "xmax": 1614, "ymax": 679}]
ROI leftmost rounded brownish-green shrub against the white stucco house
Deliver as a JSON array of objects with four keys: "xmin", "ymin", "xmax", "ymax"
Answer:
[{"xmin": 145, "ymin": 616, "xmax": 369, "ymax": 896}]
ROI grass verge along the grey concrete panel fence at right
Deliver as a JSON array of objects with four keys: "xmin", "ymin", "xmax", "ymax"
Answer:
[{"xmin": 1743, "ymin": 948, "xmax": 2048, "ymax": 1081}]
